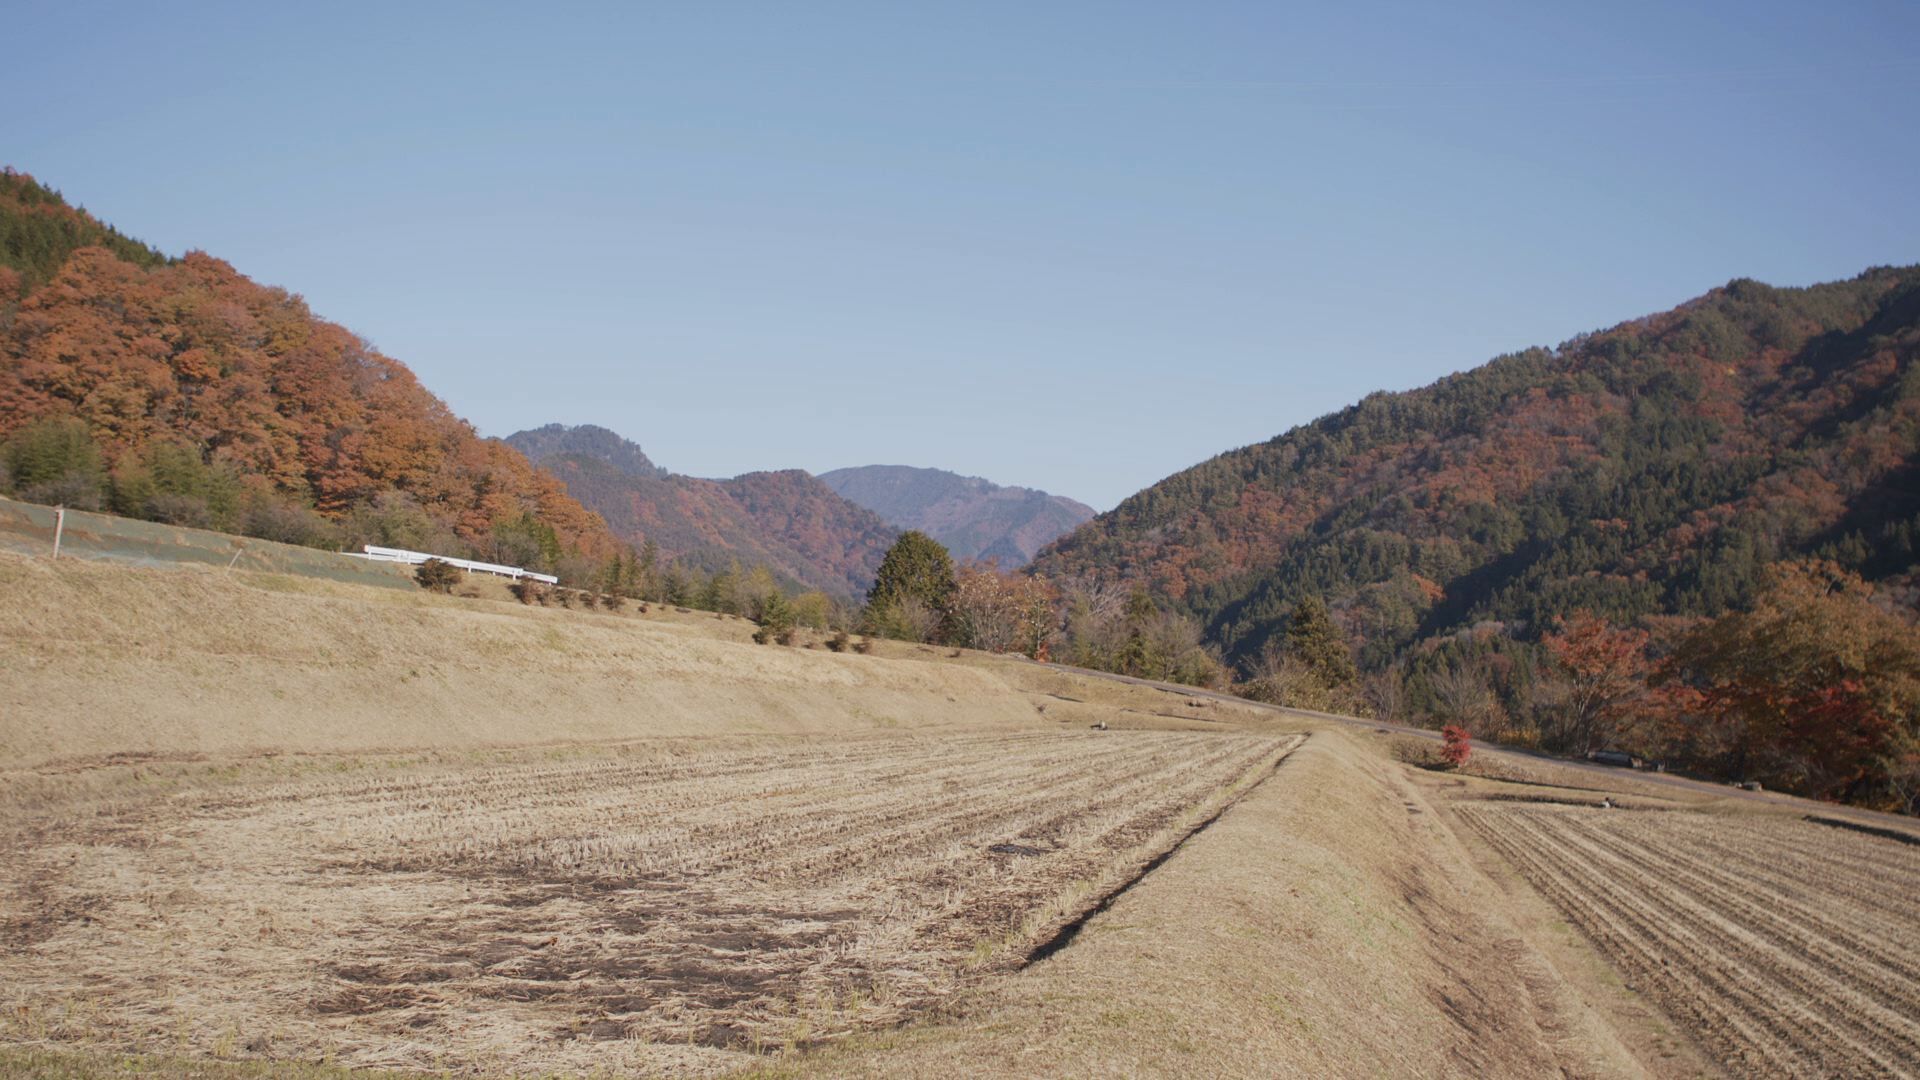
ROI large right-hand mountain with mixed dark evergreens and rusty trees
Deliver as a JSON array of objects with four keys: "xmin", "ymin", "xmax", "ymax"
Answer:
[{"xmin": 1035, "ymin": 267, "xmax": 1920, "ymax": 671}]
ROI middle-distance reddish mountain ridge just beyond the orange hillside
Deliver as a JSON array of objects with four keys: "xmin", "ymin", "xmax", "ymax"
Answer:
[{"xmin": 507, "ymin": 425, "xmax": 895, "ymax": 600}]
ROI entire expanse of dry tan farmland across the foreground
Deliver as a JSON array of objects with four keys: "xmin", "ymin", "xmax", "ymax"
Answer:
[{"xmin": 0, "ymin": 555, "xmax": 1920, "ymax": 1080}]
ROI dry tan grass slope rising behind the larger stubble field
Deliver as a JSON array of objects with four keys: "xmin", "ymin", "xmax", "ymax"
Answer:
[{"xmin": 0, "ymin": 553, "xmax": 1043, "ymax": 771}]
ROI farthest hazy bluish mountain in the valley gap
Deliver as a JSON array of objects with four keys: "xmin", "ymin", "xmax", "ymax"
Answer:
[{"xmin": 820, "ymin": 465, "xmax": 1092, "ymax": 569}]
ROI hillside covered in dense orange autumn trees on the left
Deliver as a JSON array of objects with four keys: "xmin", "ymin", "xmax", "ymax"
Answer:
[{"xmin": 0, "ymin": 171, "xmax": 614, "ymax": 567}]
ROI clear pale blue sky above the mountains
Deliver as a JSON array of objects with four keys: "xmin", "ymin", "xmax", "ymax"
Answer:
[{"xmin": 0, "ymin": 0, "xmax": 1920, "ymax": 509}]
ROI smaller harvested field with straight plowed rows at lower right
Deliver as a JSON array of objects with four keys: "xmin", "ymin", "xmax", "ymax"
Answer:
[{"xmin": 1459, "ymin": 803, "xmax": 1920, "ymax": 1076}]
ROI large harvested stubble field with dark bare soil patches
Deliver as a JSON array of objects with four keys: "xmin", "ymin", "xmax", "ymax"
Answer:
[{"xmin": 0, "ymin": 732, "xmax": 1298, "ymax": 1072}]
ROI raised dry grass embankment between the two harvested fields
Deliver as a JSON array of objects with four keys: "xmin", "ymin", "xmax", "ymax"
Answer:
[{"xmin": 755, "ymin": 732, "xmax": 1644, "ymax": 1080}]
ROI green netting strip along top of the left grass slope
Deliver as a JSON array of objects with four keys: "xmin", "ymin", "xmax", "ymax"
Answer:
[{"xmin": 0, "ymin": 500, "xmax": 415, "ymax": 588}]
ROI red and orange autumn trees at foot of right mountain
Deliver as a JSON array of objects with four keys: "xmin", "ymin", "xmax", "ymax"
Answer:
[{"xmin": 1240, "ymin": 559, "xmax": 1920, "ymax": 813}]
